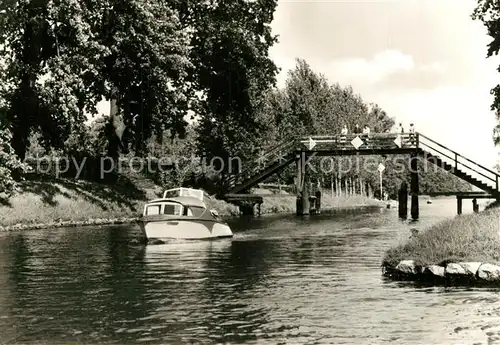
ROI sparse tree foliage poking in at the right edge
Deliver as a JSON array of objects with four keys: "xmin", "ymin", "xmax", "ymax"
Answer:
[{"xmin": 472, "ymin": 0, "xmax": 500, "ymax": 145}]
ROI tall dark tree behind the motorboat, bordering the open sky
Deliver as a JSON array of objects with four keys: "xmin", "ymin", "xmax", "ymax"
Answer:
[{"xmin": 182, "ymin": 0, "xmax": 277, "ymax": 176}]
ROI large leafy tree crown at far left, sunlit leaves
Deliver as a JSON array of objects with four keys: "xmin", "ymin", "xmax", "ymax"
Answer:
[{"xmin": 0, "ymin": 0, "xmax": 191, "ymax": 158}]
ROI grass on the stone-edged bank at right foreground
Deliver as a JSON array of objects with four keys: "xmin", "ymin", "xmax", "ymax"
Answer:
[{"xmin": 382, "ymin": 209, "xmax": 500, "ymax": 267}]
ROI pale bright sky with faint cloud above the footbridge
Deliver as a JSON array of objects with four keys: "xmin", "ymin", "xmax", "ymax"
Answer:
[{"xmin": 271, "ymin": 0, "xmax": 500, "ymax": 167}]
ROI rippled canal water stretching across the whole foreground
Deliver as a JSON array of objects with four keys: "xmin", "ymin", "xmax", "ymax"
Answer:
[{"xmin": 0, "ymin": 199, "xmax": 500, "ymax": 345}]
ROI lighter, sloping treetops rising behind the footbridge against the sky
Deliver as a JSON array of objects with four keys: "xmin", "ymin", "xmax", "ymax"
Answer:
[{"xmin": 261, "ymin": 59, "xmax": 394, "ymax": 144}]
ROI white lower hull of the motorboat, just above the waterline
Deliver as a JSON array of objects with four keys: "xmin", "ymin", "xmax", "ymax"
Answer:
[{"xmin": 142, "ymin": 219, "xmax": 233, "ymax": 240}]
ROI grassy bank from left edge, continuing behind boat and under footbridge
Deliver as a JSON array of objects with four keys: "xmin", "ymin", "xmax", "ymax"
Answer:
[{"xmin": 0, "ymin": 180, "xmax": 380, "ymax": 229}]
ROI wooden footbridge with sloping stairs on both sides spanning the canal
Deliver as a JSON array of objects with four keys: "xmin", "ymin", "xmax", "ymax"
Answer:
[{"xmin": 222, "ymin": 133, "xmax": 500, "ymax": 219}]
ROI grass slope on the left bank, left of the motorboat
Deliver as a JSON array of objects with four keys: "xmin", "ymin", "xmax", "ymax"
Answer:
[{"xmin": 0, "ymin": 176, "xmax": 152, "ymax": 226}]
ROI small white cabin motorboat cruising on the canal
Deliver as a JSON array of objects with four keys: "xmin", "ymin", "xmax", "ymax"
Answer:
[{"xmin": 139, "ymin": 188, "xmax": 233, "ymax": 241}]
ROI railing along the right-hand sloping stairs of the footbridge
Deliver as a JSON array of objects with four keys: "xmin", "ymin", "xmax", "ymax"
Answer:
[{"xmin": 417, "ymin": 133, "xmax": 500, "ymax": 191}]
